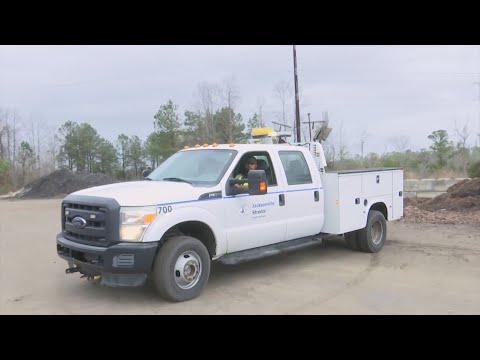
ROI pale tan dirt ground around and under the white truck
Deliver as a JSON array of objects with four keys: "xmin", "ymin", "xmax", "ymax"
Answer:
[{"xmin": 0, "ymin": 200, "xmax": 480, "ymax": 314}]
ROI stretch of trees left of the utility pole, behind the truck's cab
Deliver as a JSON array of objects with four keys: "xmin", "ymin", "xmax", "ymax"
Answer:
[{"xmin": 0, "ymin": 78, "xmax": 280, "ymax": 193}]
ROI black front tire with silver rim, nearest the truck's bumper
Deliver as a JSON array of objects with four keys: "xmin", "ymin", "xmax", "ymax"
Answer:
[{"xmin": 151, "ymin": 236, "xmax": 210, "ymax": 302}]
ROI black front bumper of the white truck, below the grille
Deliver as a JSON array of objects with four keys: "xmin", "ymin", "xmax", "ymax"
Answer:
[{"xmin": 57, "ymin": 234, "xmax": 158, "ymax": 287}]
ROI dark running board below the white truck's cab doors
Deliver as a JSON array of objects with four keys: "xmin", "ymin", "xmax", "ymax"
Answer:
[{"xmin": 217, "ymin": 236, "xmax": 322, "ymax": 265}]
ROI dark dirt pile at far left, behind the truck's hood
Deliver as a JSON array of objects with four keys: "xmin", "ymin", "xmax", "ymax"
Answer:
[{"xmin": 15, "ymin": 169, "xmax": 118, "ymax": 199}]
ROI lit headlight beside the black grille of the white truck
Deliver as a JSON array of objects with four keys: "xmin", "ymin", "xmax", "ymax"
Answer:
[{"xmin": 120, "ymin": 206, "xmax": 157, "ymax": 241}]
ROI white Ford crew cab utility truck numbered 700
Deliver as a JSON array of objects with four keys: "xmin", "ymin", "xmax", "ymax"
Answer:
[{"xmin": 56, "ymin": 134, "xmax": 403, "ymax": 301}]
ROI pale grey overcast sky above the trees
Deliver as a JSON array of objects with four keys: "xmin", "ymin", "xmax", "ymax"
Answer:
[{"xmin": 0, "ymin": 45, "xmax": 480, "ymax": 152}]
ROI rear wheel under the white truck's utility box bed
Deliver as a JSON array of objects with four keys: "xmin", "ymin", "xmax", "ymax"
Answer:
[{"xmin": 358, "ymin": 210, "xmax": 387, "ymax": 253}]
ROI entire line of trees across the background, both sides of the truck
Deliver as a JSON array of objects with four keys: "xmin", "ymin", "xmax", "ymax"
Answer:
[{"xmin": 0, "ymin": 78, "xmax": 480, "ymax": 194}]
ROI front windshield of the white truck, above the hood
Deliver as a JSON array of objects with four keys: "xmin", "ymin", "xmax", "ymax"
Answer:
[{"xmin": 147, "ymin": 149, "xmax": 237, "ymax": 186}]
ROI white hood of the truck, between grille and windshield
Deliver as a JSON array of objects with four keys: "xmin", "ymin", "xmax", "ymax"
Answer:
[{"xmin": 72, "ymin": 181, "xmax": 210, "ymax": 206}]
